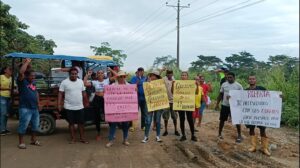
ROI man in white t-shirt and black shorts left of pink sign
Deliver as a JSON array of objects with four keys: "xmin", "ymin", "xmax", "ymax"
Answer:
[{"xmin": 58, "ymin": 67, "xmax": 89, "ymax": 144}]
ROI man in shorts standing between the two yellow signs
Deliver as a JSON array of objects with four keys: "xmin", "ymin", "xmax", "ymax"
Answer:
[{"xmin": 163, "ymin": 70, "xmax": 180, "ymax": 136}]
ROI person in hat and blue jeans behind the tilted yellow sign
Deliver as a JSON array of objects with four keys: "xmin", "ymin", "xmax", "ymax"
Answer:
[{"xmin": 142, "ymin": 71, "xmax": 163, "ymax": 143}]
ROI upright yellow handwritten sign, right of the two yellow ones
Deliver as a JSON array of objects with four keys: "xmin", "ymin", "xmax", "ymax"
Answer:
[{"xmin": 173, "ymin": 80, "xmax": 196, "ymax": 111}]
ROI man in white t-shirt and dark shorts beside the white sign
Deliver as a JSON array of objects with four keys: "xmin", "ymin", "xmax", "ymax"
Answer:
[{"xmin": 216, "ymin": 72, "xmax": 243, "ymax": 143}]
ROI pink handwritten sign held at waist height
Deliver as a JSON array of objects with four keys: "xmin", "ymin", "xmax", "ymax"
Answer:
[{"xmin": 104, "ymin": 85, "xmax": 138, "ymax": 122}]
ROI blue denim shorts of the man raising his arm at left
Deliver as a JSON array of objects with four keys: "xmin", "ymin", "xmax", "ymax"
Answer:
[{"xmin": 18, "ymin": 107, "xmax": 40, "ymax": 135}]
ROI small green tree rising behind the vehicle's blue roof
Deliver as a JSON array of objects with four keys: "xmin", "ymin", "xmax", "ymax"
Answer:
[{"xmin": 90, "ymin": 42, "xmax": 127, "ymax": 67}]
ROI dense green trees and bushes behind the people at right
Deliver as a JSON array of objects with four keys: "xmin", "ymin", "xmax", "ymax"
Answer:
[{"xmin": 153, "ymin": 54, "xmax": 299, "ymax": 128}]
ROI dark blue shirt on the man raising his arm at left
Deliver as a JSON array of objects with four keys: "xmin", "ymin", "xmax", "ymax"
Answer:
[{"xmin": 18, "ymin": 79, "xmax": 38, "ymax": 109}]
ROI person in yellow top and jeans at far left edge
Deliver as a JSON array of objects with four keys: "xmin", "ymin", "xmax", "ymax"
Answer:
[{"xmin": 0, "ymin": 66, "xmax": 12, "ymax": 135}]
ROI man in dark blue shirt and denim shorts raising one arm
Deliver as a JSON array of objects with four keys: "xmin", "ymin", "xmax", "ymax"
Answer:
[{"xmin": 17, "ymin": 58, "xmax": 41, "ymax": 149}]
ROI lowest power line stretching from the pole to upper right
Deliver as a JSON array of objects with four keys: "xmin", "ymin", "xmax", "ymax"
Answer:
[{"xmin": 181, "ymin": 0, "xmax": 265, "ymax": 28}]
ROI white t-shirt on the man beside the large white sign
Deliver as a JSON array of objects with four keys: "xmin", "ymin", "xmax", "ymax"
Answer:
[{"xmin": 220, "ymin": 81, "xmax": 243, "ymax": 107}]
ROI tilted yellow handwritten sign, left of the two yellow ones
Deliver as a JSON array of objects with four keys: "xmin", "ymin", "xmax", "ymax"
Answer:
[{"xmin": 143, "ymin": 79, "xmax": 170, "ymax": 112}]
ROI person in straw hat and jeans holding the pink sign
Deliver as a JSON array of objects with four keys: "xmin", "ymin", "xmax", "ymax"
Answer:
[{"xmin": 106, "ymin": 71, "xmax": 130, "ymax": 148}]
